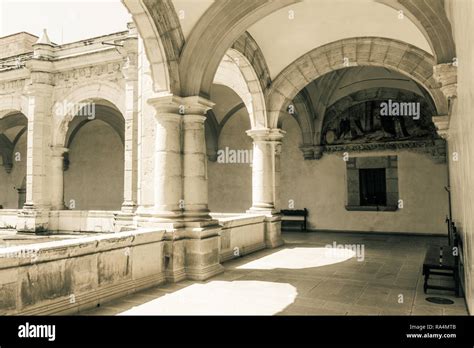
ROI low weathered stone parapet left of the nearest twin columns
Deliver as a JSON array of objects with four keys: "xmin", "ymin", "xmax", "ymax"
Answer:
[{"xmin": 0, "ymin": 230, "xmax": 165, "ymax": 315}]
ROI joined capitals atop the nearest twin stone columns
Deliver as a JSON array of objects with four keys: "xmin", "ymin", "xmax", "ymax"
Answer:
[{"xmin": 148, "ymin": 94, "xmax": 215, "ymax": 116}]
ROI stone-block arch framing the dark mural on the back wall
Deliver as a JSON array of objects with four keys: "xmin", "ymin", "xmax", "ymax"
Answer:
[{"xmin": 266, "ymin": 37, "xmax": 448, "ymax": 128}]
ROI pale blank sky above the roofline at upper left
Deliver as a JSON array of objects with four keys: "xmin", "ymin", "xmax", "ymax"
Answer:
[{"xmin": 0, "ymin": 0, "xmax": 132, "ymax": 44}]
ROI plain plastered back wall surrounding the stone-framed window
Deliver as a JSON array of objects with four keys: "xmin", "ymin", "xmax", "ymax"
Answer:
[{"xmin": 280, "ymin": 118, "xmax": 448, "ymax": 234}]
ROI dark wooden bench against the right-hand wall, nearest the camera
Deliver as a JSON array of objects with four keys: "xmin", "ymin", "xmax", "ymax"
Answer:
[{"xmin": 423, "ymin": 219, "xmax": 462, "ymax": 296}]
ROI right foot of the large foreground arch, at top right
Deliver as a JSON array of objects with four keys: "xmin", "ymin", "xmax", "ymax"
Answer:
[{"xmin": 375, "ymin": 0, "xmax": 456, "ymax": 64}]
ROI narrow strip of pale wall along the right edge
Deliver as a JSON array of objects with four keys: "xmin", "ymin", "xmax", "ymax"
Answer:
[{"xmin": 447, "ymin": 0, "xmax": 474, "ymax": 314}]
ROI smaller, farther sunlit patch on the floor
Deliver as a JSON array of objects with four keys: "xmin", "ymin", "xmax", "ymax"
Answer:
[{"xmin": 237, "ymin": 247, "xmax": 356, "ymax": 269}]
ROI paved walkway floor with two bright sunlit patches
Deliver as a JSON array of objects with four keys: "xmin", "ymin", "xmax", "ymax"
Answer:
[{"xmin": 82, "ymin": 232, "xmax": 467, "ymax": 315}]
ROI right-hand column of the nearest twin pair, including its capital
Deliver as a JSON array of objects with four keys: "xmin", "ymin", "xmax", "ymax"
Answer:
[{"xmin": 183, "ymin": 97, "xmax": 214, "ymax": 221}]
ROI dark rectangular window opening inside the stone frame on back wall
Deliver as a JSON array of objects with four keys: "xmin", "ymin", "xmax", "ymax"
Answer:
[{"xmin": 359, "ymin": 168, "xmax": 387, "ymax": 206}]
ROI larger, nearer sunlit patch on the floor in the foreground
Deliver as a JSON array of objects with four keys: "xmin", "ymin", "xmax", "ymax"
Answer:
[{"xmin": 119, "ymin": 281, "xmax": 297, "ymax": 315}]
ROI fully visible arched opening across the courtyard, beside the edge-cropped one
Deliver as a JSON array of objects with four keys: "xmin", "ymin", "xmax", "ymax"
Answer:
[{"xmin": 60, "ymin": 98, "xmax": 125, "ymax": 210}]
